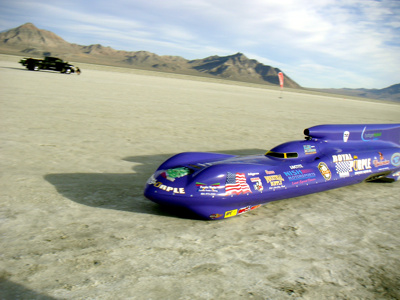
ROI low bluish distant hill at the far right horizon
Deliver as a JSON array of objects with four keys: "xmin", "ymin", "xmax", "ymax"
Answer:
[{"xmin": 313, "ymin": 84, "xmax": 400, "ymax": 101}]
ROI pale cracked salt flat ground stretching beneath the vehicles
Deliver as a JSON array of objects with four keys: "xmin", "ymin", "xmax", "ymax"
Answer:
[{"xmin": 0, "ymin": 56, "xmax": 400, "ymax": 299}]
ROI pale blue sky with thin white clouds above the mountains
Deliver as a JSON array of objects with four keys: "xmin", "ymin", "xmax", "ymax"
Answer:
[{"xmin": 0, "ymin": 0, "xmax": 400, "ymax": 89}]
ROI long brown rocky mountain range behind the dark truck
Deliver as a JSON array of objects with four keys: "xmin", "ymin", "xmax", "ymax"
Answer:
[{"xmin": 0, "ymin": 23, "xmax": 301, "ymax": 89}]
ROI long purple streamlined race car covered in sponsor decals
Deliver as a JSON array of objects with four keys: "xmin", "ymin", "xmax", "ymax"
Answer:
[{"xmin": 144, "ymin": 124, "xmax": 400, "ymax": 220}]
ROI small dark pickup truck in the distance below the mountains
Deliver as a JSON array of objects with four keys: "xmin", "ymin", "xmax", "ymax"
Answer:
[{"xmin": 19, "ymin": 56, "xmax": 75, "ymax": 74}]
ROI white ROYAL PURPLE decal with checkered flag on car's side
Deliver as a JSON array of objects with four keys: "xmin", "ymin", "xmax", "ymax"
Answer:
[{"xmin": 332, "ymin": 154, "xmax": 371, "ymax": 178}]
